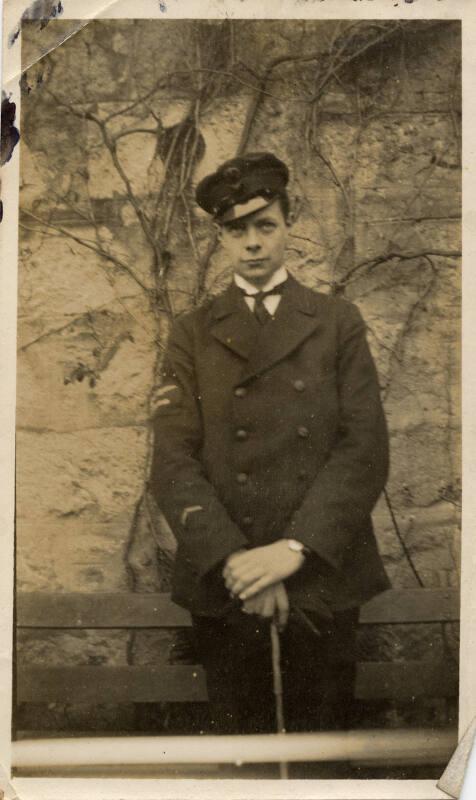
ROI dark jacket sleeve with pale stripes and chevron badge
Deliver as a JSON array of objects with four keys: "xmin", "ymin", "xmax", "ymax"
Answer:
[{"xmin": 149, "ymin": 320, "xmax": 247, "ymax": 577}]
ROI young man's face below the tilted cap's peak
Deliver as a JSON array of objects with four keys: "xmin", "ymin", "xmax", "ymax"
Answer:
[{"xmin": 220, "ymin": 200, "xmax": 289, "ymax": 287}]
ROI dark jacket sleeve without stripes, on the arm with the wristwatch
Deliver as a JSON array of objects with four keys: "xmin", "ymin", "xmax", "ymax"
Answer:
[{"xmin": 285, "ymin": 302, "xmax": 388, "ymax": 569}]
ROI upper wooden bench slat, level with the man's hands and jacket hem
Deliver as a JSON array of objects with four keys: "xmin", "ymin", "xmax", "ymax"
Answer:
[{"xmin": 17, "ymin": 589, "xmax": 459, "ymax": 629}]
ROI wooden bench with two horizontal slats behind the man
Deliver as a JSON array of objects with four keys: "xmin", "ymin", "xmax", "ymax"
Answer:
[{"xmin": 16, "ymin": 589, "xmax": 459, "ymax": 704}]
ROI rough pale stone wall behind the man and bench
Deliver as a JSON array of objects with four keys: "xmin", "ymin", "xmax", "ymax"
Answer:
[{"xmin": 17, "ymin": 20, "xmax": 461, "ymax": 729}]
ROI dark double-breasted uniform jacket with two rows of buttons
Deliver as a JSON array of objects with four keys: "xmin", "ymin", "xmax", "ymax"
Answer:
[{"xmin": 151, "ymin": 276, "xmax": 389, "ymax": 615}]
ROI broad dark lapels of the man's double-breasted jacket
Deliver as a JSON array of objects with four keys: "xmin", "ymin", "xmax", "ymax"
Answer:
[{"xmin": 211, "ymin": 276, "xmax": 321, "ymax": 382}]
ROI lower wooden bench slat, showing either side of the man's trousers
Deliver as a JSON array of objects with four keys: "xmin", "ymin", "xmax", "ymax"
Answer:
[{"xmin": 17, "ymin": 661, "xmax": 458, "ymax": 704}]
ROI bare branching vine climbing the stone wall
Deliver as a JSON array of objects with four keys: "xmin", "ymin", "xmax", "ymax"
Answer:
[{"xmin": 21, "ymin": 20, "xmax": 461, "ymax": 692}]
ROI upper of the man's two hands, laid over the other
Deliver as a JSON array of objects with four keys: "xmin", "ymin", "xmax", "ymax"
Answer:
[{"xmin": 223, "ymin": 539, "xmax": 304, "ymax": 600}]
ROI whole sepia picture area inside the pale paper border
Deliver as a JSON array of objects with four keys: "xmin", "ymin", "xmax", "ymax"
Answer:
[{"xmin": 2, "ymin": 3, "xmax": 468, "ymax": 797}]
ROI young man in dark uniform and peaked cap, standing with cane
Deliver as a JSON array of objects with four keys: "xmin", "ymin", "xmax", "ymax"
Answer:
[{"xmin": 151, "ymin": 153, "xmax": 389, "ymax": 733}]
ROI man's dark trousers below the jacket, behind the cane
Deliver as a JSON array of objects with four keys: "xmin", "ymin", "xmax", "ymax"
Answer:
[{"xmin": 193, "ymin": 608, "xmax": 359, "ymax": 734}]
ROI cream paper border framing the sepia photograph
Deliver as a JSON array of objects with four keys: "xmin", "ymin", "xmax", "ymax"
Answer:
[{"xmin": 0, "ymin": 0, "xmax": 476, "ymax": 800}]
